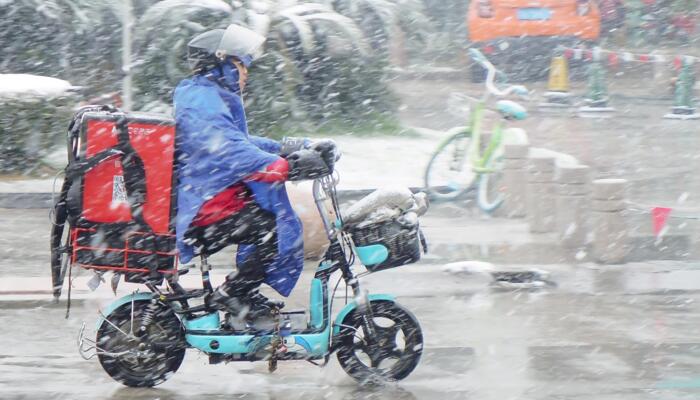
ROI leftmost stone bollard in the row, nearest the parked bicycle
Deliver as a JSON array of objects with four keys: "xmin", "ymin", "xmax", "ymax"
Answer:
[{"xmin": 501, "ymin": 144, "xmax": 530, "ymax": 218}]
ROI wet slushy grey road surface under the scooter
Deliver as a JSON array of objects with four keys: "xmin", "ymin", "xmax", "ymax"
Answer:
[{"xmin": 5, "ymin": 262, "xmax": 700, "ymax": 400}]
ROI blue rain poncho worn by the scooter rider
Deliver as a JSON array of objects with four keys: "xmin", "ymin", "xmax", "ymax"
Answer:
[{"xmin": 174, "ymin": 63, "xmax": 304, "ymax": 296}]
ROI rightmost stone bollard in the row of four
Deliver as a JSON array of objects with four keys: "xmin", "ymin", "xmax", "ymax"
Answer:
[{"xmin": 591, "ymin": 179, "xmax": 629, "ymax": 264}]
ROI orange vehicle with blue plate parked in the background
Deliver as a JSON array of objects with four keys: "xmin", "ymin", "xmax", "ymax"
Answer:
[{"xmin": 467, "ymin": 0, "xmax": 600, "ymax": 81}]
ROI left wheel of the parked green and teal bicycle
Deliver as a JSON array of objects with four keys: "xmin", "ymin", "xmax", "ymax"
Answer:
[{"xmin": 424, "ymin": 127, "xmax": 476, "ymax": 200}]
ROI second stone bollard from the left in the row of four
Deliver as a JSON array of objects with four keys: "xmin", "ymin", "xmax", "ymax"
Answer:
[{"xmin": 526, "ymin": 157, "xmax": 557, "ymax": 233}]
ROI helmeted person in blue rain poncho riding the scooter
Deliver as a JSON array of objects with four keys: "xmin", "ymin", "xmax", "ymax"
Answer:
[{"xmin": 173, "ymin": 25, "xmax": 336, "ymax": 318}]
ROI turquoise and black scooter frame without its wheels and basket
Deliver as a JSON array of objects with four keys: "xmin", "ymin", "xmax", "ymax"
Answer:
[{"xmin": 78, "ymin": 176, "xmax": 395, "ymax": 362}]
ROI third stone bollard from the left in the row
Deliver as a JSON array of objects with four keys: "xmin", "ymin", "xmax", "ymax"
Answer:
[{"xmin": 556, "ymin": 165, "xmax": 591, "ymax": 249}]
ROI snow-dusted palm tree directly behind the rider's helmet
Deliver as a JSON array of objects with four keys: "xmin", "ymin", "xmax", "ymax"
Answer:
[{"xmin": 135, "ymin": 0, "xmax": 386, "ymax": 134}]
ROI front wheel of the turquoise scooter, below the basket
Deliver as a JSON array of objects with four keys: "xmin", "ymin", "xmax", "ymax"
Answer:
[{"xmin": 335, "ymin": 301, "xmax": 423, "ymax": 384}]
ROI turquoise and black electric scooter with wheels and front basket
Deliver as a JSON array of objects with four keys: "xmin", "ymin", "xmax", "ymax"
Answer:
[{"xmin": 78, "ymin": 175, "xmax": 426, "ymax": 387}]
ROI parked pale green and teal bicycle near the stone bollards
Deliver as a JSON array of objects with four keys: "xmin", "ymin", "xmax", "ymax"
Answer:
[{"xmin": 424, "ymin": 49, "xmax": 528, "ymax": 213}]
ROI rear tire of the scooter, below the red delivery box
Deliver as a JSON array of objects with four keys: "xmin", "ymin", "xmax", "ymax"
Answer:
[{"xmin": 96, "ymin": 301, "xmax": 186, "ymax": 387}]
